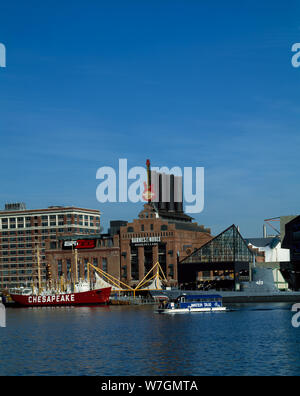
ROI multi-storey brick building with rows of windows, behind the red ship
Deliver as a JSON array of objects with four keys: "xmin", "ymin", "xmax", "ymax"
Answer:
[{"xmin": 0, "ymin": 204, "xmax": 100, "ymax": 289}]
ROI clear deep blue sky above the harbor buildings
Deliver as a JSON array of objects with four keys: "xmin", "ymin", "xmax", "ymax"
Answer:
[{"xmin": 0, "ymin": 0, "xmax": 300, "ymax": 237}]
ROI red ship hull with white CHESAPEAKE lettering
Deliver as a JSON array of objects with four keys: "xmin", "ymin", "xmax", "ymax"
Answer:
[{"xmin": 11, "ymin": 287, "xmax": 111, "ymax": 307}]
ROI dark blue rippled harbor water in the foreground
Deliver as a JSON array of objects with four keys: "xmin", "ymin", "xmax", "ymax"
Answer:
[{"xmin": 0, "ymin": 304, "xmax": 300, "ymax": 376}]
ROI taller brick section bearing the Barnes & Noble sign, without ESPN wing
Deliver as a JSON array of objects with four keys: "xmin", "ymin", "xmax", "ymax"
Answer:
[{"xmin": 120, "ymin": 203, "xmax": 212, "ymax": 286}]
